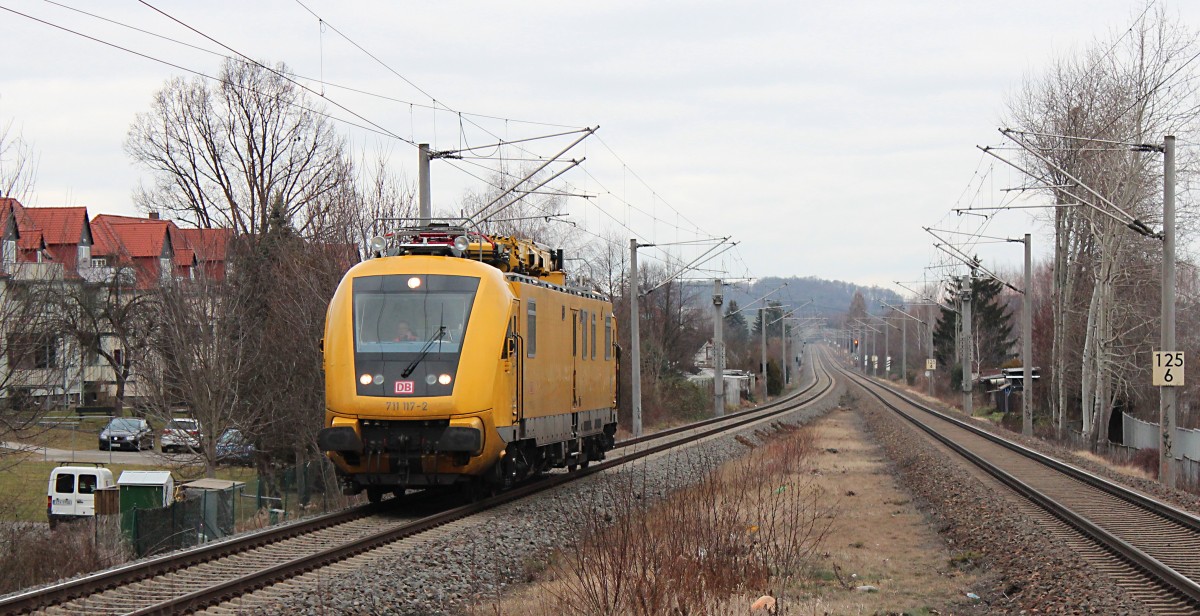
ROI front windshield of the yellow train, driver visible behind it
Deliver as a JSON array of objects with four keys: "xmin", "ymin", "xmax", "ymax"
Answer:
[{"xmin": 354, "ymin": 274, "xmax": 479, "ymax": 355}]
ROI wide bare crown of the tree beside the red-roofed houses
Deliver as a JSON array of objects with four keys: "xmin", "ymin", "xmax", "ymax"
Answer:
[{"xmin": 125, "ymin": 59, "xmax": 353, "ymax": 235}]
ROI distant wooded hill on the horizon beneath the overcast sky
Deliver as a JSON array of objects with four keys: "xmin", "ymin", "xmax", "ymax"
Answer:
[{"xmin": 690, "ymin": 276, "xmax": 904, "ymax": 321}]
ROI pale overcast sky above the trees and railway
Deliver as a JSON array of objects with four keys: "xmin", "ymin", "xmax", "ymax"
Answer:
[{"xmin": 0, "ymin": 0, "xmax": 1200, "ymax": 290}]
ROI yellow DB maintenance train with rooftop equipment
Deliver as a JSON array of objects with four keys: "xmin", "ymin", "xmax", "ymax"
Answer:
[{"xmin": 318, "ymin": 222, "xmax": 619, "ymax": 502}]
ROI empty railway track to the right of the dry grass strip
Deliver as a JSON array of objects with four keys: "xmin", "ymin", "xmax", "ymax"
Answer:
[{"xmin": 839, "ymin": 350, "xmax": 1200, "ymax": 615}]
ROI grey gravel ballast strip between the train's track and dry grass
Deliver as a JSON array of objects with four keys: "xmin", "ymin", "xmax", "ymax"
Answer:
[{"xmin": 254, "ymin": 384, "xmax": 845, "ymax": 615}]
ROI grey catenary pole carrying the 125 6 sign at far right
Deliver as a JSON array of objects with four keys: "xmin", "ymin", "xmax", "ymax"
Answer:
[{"xmin": 1158, "ymin": 134, "xmax": 1175, "ymax": 488}]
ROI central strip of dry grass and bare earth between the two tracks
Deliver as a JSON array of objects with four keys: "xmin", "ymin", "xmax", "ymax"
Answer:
[{"xmin": 473, "ymin": 411, "xmax": 974, "ymax": 616}]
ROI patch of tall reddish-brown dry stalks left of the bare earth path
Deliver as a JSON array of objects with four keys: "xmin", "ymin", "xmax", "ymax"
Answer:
[{"xmin": 478, "ymin": 424, "xmax": 833, "ymax": 615}]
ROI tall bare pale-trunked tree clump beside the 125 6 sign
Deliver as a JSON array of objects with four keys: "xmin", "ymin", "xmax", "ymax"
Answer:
[{"xmin": 1009, "ymin": 10, "xmax": 1200, "ymax": 442}]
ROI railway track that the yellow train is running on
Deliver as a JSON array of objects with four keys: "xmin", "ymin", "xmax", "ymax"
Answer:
[{"xmin": 0, "ymin": 353, "xmax": 834, "ymax": 615}]
